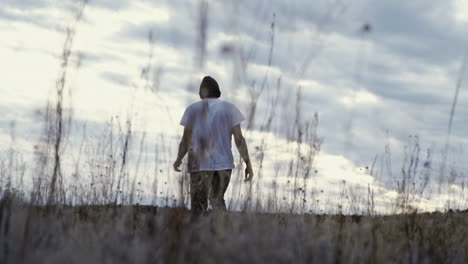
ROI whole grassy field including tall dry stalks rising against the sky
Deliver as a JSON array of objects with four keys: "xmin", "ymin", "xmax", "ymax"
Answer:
[{"xmin": 0, "ymin": 1, "xmax": 468, "ymax": 264}]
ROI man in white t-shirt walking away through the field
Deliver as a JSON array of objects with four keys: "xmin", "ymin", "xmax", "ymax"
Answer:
[{"xmin": 174, "ymin": 76, "xmax": 254, "ymax": 215}]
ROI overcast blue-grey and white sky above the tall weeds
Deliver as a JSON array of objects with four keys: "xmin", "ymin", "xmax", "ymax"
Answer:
[{"xmin": 0, "ymin": 0, "xmax": 468, "ymax": 210}]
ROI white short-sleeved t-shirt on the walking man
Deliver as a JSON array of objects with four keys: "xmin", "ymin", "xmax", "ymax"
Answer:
[{"xmin": 180, "ymin": 98, "xmax": 245, "ymax": 172}]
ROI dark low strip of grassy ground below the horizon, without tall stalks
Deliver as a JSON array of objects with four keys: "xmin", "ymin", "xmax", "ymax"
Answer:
[{"xmin": 0, "ymin": 197, "xmax": 468, "ymax": 264}]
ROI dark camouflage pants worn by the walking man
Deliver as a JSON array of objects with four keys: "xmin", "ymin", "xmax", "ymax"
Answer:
[{"xmin": 190, "ymin": 170, "xmax": 232, "ymax": 214}]
